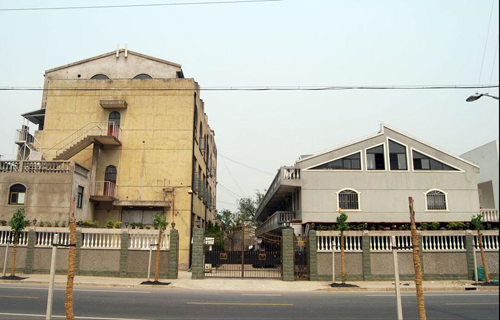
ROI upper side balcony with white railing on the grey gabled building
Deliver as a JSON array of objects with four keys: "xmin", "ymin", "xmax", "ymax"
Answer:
[{"xmin": 255, "ymin": 167, "xmax": 301, "ymax": 221}]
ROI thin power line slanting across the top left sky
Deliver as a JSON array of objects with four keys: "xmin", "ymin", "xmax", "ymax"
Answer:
[{"xmin": 0, "ymin": 0, "xmax": 286, "ymax": 12}]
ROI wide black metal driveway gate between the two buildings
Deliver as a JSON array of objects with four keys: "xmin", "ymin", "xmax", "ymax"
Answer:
[{"xmin": 205, "ymin": 229, "xmax": 282, "ymax": 279}]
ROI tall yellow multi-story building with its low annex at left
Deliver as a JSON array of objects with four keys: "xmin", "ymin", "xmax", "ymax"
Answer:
[{"xmin": 0, "ymin": 50, "xmax": 217, "ymax": 268}]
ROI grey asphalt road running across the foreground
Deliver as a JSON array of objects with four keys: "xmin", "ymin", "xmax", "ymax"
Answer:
[{"xmin": 0, "ymin": 284, "xmax": 499, "ymax": 320}]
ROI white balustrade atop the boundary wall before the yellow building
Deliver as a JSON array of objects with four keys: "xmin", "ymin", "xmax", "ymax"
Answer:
[{"xmin": 0, "ymin": 227, "xmax": 170, "ymax": 250}]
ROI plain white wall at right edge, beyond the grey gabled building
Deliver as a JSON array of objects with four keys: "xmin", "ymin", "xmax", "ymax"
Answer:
[{"xmin": 462, "ymin": 140, "xmax": 500, "ymax": 210}]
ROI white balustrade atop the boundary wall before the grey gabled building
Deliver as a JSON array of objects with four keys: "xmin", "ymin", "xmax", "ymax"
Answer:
[{"xmin": 317, "ymin": 231, "xmax": 499, "ymax": 252}]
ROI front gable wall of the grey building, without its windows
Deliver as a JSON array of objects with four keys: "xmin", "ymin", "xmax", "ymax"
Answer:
[{"xmin": 296, "ymin": 128, "xmax": 479, "ymax": 223}]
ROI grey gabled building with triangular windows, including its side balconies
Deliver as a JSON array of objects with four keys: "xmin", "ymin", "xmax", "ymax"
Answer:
[{"xmin": 256, "ymin": 125, "xmax": 488, "ymax": 234}]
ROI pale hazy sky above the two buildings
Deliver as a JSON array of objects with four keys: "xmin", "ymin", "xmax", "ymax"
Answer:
[{"xmin": 0, "ymin": 0, "xmax": 499, "ymax": 209}]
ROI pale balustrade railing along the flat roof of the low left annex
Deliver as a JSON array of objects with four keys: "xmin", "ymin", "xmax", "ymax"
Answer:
[{"xmin": 0, "ymin": 161, "xmax": 71, "ymax": 173}]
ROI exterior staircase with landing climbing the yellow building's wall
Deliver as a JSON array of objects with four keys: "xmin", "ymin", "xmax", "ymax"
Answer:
[{"xmin": 44, "ymin": 122, "xmax": 122, "ymax": 160}]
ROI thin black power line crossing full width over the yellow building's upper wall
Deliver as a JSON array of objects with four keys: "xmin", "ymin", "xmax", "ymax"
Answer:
[{"xmin": 0, "ymin": 84, "xmax": 500, "ymax": 92}]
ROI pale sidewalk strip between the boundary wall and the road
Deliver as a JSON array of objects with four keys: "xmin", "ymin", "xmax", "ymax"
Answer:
[{"xmin": 0, "ymin": 272, "xmax": 499, "ymax": 292}]
